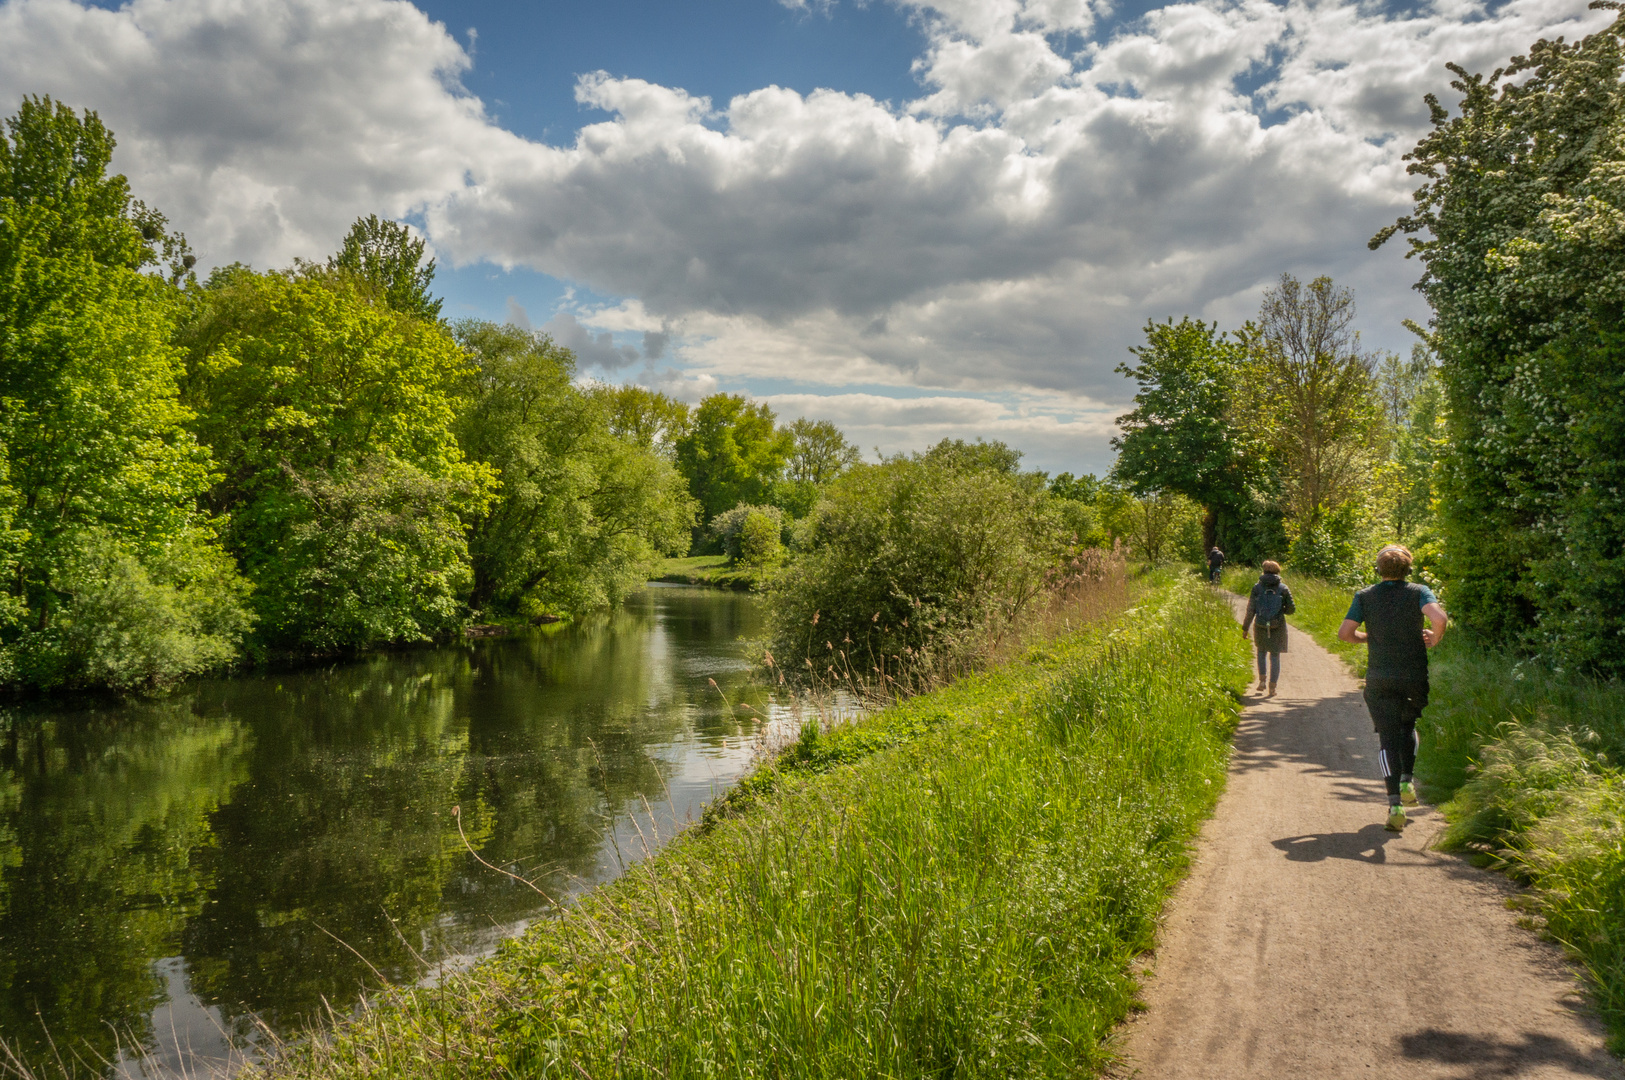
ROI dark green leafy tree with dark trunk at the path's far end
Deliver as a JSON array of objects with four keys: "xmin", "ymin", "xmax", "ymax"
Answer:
[{"xmin": 1112, "ymin": 317, "xmax": 1269, "ymax": 554}]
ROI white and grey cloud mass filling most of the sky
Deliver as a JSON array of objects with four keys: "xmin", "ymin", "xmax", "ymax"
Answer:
[{"xmin": 0, "ymin": 0, "xmax": 1610, "ymax": 464}]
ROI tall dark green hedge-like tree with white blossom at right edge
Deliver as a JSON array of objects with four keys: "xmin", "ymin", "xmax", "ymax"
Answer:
[{"xmin": 1372, "ymin": 10, "xmax": 1625, "ymax": 665}]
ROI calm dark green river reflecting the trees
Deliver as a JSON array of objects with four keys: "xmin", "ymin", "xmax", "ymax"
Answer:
[{"xmin": 0, "ymin": 586, "xmax": 786, "ymax": 1074}]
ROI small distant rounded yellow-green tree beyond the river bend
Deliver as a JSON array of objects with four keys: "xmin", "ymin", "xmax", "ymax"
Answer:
[{"xmin": 676, "ymin": 393, "xmax": 795, "ymax": 523}]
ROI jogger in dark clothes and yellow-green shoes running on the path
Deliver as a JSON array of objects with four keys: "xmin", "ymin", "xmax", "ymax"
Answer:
[{"xmin": 1337, "ymin": 544, "xmax": 1448, "ymax": 833}]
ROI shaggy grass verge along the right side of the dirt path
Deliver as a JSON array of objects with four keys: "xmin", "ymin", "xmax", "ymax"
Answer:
[{"xmin": 1225, "ymin": 558, "xmax": 1625, "ymax": 1054}]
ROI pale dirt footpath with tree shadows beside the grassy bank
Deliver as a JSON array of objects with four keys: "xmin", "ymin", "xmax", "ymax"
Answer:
[{"xmin": 1121, "ymin": 601, "xmax": 1625, "ymax": 1080}]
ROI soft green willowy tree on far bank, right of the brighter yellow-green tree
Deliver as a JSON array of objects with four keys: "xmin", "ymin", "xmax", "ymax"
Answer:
[{"xmin": 457, "ymin": 322, "xmax": 694, "ymax": 614}]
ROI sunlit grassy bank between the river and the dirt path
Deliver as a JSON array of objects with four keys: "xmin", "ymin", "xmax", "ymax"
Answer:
[{"xmin": 271, "ymin": 578, "xmax": 1246, "ymax": 1077}]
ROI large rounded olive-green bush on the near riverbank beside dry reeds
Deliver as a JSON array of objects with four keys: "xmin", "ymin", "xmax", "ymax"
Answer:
[{"xmin": 769, "ymin": 440, "xmax": 1068, "ymax": 674}]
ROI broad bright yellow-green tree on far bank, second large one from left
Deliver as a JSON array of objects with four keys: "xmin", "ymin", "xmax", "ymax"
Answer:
[{"xmin": 182, "ymin": 268, "xmax": 494, "ymax": 651}]
